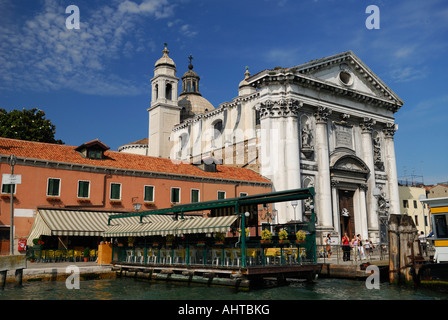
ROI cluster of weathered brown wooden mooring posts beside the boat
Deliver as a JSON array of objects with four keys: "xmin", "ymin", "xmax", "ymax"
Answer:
[{"xmin": 389, "ymin": 214, "xmax": 420, "ymax": 284}]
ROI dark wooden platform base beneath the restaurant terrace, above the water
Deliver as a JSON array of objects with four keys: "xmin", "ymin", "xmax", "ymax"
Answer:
[{"xmin": 112, "ymin": 262, "xmax": 321, "ymax": 290}]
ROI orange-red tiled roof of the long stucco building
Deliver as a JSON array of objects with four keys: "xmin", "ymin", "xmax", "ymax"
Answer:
[{"xmin": 0, "ymin": 137, "xmax": 271, "ymax": 183}]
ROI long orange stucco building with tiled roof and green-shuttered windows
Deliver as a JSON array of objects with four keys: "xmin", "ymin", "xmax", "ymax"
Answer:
[{"xmin": 0, "ymin": 138, "xmax": 272, "ymax": 253}]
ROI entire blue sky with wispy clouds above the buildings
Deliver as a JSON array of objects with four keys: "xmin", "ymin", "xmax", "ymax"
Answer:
[{"xmin": 0, "ymin": 0, "xmax": 448, "ymax": 183}]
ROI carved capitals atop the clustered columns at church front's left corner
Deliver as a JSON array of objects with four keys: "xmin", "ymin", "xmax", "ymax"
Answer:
[{"xmin": 256, "ymin": 98, "xmax": 303, "ymax": 119}]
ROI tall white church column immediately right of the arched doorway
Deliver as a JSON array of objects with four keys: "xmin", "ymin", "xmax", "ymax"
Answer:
[{"xmin": 360, "ymin": 118, "xmax": 378, "ymax": 237}]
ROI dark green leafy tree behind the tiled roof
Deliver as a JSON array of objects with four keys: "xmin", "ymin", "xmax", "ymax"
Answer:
[{"xmin": 0, "ymin": 108, "xmax": 64, "ymax": 144}]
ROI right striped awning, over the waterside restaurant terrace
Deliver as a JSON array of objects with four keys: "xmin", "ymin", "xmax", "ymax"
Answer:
[{"xmin": 103, "ymin": 215, "xmax": 238, "ymax": 237}]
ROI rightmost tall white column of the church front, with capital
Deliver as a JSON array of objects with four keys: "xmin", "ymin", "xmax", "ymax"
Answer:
[{"xmin": 383, "ymin": 123, "xmax": 400, "ymax": 214}]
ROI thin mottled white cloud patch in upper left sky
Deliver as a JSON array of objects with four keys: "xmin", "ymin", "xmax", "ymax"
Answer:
[{"xmin": 0, "ymin": 0, "xmax": 173, "ymax": 95}]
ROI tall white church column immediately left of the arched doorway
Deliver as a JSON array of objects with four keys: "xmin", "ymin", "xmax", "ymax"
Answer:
[{"xmin": 314, "ymin": 106, "xmax": 333, "ymax": 230}]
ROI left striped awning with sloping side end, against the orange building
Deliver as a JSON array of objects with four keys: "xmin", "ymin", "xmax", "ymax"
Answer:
[{"xmin": 28, "ymin": 209, "xmax": 177, "ymax": 242}]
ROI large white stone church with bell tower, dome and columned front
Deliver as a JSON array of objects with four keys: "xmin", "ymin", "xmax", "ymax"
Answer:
[{"xmin": 133, "ymin": 43, "xmax": 403, "ymax": 242}]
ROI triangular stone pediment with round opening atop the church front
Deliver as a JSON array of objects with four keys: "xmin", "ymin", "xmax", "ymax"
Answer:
[{"xmin": 295, "ymin": 51, "xmax": 403, "ymax": 105}]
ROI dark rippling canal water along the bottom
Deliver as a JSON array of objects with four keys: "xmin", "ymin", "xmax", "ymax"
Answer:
[{"xmin": 0, "ymin": 278, "xmax": 448, "ymax": 301}]
